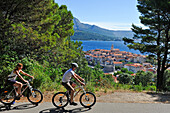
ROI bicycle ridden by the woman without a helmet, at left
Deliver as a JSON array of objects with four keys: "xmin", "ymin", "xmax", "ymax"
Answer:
[{"xmin": 0, "ymin": 79, "xmax": 43, "ymax": 105}]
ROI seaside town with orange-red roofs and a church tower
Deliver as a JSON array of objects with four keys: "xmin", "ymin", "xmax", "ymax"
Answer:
[{"xmin": 85, "ymin": 44, "xmax": 156, "ymax": 74}]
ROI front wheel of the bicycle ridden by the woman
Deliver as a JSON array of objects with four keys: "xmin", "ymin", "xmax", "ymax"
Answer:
[{"xmin": 27, "ymin": 89, "xmax": 43, "ymax": 104}]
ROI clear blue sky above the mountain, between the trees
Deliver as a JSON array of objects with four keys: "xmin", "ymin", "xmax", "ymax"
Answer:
[{"xmin": 55, "ymin": 0, "xmax": 144, "ymax": 30}]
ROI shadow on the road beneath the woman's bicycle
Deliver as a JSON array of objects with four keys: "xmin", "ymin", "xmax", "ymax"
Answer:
[{"xmin": 0, "ymin": 104, "xmax": 36, "ymax": 112}]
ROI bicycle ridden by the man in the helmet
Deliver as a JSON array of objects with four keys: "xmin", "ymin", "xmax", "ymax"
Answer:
[{"xmin": 52, "ymin": 82, "xmax": 96, "ymax": 108}]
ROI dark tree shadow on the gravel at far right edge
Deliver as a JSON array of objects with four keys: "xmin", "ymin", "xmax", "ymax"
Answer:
[{"xmin": 147, "ymin": 92, "xmax": 170, "ymax": 104}]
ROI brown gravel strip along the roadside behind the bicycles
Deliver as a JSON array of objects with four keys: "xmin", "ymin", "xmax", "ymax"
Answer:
[{"xmin": 12, "ymin": 91, "xmax": 170, "ymax": 104}]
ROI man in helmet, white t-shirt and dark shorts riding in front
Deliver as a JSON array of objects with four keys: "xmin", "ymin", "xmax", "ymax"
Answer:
[{"xmin": 62, "ymin": 63, "xmax": 85, "ymax": 105}]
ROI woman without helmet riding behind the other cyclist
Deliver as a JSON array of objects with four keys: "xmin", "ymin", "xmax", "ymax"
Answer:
[{"xmin": 7, "ymin": 63, "xmax": 34, "ymax": 97}]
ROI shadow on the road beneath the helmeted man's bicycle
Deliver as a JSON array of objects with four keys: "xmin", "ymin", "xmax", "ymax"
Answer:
[{"xmin": 39, "ymin": 107, "xmax": 91, "ymax": 113}]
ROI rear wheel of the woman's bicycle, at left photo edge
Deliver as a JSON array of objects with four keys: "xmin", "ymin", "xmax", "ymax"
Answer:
[{"xmin": 0, "ymin": 89, "xmax": 16, "ymax": 105}]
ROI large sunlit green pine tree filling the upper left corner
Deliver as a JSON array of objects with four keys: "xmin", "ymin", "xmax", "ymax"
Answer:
[{"xmin": 0, "ymin": 0, "xmax": 74, "ymax": 59}]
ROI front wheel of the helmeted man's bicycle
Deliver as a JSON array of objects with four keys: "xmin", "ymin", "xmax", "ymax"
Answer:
[{"xmin": 80, "ymin": 92, "xmax": 96, "ymax": 108}]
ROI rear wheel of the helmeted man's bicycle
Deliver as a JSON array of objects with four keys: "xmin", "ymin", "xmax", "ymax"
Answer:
[{"xmin": 52, "ymin": 92, "xmax": 69, "ymax": 108}]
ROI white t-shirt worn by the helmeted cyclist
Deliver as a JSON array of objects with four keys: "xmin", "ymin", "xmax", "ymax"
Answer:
[{"xmin": 62, "ymin": 69, "xmax": 75, "ymax": 82}]
